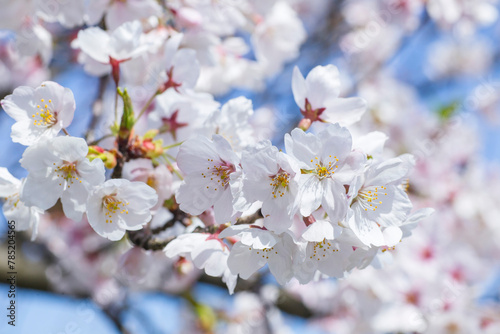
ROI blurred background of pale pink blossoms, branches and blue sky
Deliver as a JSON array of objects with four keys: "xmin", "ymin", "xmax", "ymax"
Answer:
[{"xmin": 0, "ymin": 0, "xmax": 500, "ymax": 334}]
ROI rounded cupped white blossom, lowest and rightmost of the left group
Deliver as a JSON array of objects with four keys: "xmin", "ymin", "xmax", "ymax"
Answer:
[{"xmin": 87, "ymin": 179, "xmax": 158, "ymax": 241}]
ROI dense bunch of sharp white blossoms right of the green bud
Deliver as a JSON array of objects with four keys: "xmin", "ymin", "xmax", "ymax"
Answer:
[{"xmin": 170, "ymin": 85, "xmax": 432, "ymax": 284}]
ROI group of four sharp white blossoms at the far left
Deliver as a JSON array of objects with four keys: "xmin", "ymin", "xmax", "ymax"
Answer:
[{"xmin": 1, "ymin": 82, "xmax": 158, "ymax": 240}]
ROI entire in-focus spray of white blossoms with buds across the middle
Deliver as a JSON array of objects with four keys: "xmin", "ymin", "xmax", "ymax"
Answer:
[{"xmin": 2, "ymin": 62, "xmax": 431, "ymax": 291}]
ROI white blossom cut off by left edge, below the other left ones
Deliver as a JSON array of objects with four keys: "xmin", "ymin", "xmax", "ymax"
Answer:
[{"xmin": 0, "ymin": 167, "xmax": 43, "ymax": 240}]
